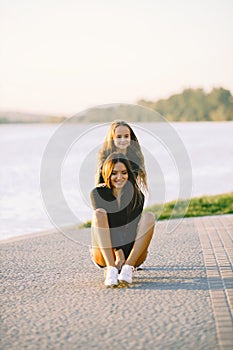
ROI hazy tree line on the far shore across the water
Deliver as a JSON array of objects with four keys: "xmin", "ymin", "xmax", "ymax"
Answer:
[{"xmin": 0, "ymin": 87, "xmax": 233, "ymax": 123}]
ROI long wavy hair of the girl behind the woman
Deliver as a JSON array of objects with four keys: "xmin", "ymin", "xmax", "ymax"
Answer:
[{"xmin": 96, "ymin": 120, "xmax": 148, "ymax": 191}]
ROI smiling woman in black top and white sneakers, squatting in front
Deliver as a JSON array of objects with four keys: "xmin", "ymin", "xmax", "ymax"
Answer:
[{"xmin": 91, "ymin": 152, "xmax": 155, "ymax": 286}]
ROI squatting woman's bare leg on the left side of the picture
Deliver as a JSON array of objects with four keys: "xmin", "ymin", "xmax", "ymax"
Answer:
[{"xmin": 92, "ymin": 209, "xmax": 115, "ymax": 267}]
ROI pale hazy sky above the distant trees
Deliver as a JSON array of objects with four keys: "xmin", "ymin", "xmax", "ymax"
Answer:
[{"xmin": 0, "ymin": 0, "xmax": 233, "ymax": 115}]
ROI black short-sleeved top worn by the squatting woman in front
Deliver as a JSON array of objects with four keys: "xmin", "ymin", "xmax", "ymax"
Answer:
[{"xmin": 90, "ymin": 182, "xmax": 144, "ymax": 249}]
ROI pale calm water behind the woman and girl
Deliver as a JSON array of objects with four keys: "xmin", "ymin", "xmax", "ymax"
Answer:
[{"xmin": 0, "ymin": 122, "xmax": 233, "ymax": 239}]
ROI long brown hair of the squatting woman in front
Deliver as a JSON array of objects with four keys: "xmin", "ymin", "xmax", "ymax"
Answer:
[{"xmin": 102, "ymin": 152, "xmax": 143, "ymax": 210}]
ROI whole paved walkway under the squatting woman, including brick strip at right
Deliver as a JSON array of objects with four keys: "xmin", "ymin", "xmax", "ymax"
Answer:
[{"xmin": 0, "ymin": 215, "xmax": 233, "ymax": 350}]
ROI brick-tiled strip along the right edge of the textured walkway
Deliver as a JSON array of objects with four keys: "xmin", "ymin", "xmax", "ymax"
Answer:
[{"xmin": 195, "ymin": 215, "xmax": 233, "ymax": 350}]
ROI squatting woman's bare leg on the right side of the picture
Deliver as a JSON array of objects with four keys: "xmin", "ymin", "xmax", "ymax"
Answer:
[{"xmin": 125, "ymin": 212, "xmax": 155, "ymax": 267}]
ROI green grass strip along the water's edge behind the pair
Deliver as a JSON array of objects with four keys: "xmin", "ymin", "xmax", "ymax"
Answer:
[{"xmin": 80, "ymin": 192, "xmax": 233, "ymax": 228}]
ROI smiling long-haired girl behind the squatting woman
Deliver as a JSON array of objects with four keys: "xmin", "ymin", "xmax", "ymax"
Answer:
[{"xmin": 96, "ymin": 120, "xmax": 147, "ymax": 190}]
